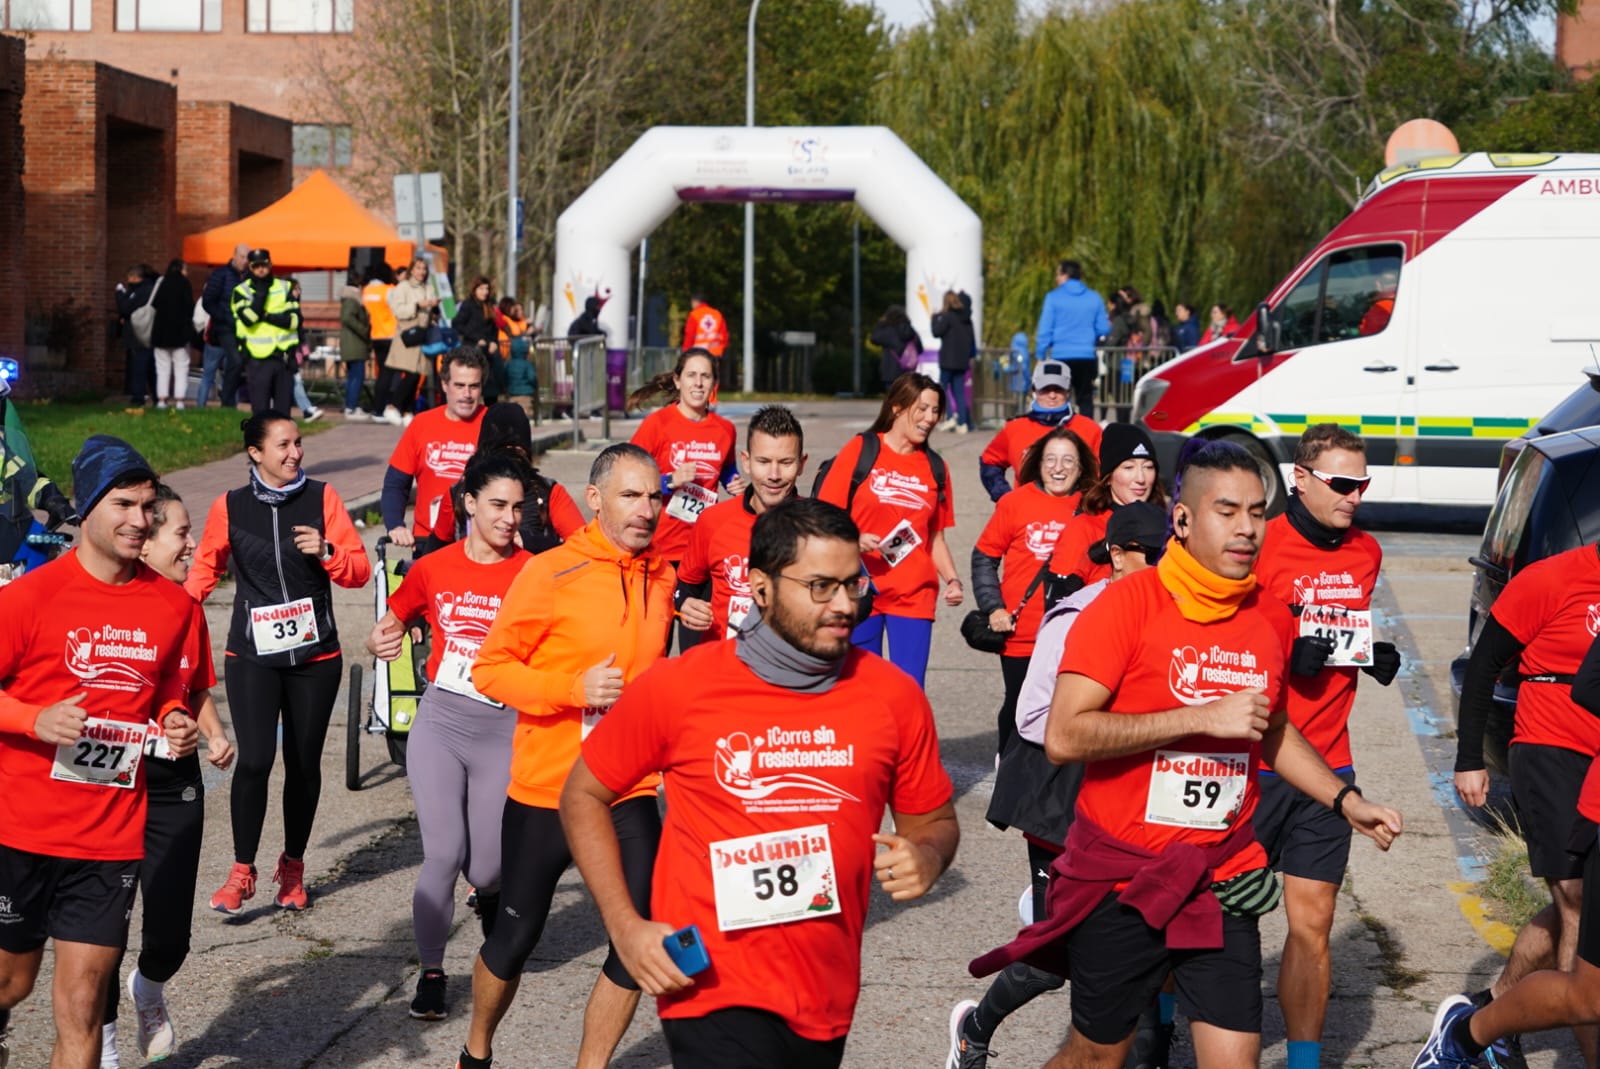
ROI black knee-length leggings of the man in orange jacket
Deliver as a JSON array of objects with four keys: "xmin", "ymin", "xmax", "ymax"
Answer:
[{"xmin": 478, "ymin": 797, "xmax": 661, "ymax": 991}]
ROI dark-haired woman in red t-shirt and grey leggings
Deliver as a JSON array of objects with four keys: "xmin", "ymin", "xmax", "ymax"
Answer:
[{"xmin": 366, "ymin": 453, "xmax": 533, "ymax": 1021}]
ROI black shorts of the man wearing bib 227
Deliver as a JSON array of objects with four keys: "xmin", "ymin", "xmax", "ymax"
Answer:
[{"xmin": 0, "ymin": 845, "xmax": 139, "ymax": 954}]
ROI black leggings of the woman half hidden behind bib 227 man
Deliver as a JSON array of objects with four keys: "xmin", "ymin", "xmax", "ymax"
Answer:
[{"xmin": 104, "ymin": 784, "xmax": 205, "ymax": 1023}]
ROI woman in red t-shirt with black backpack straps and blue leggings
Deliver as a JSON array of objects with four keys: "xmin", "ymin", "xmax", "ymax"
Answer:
[{"xmin": 816, "ymin": 371, "xmax": 965, "ymax": 685}]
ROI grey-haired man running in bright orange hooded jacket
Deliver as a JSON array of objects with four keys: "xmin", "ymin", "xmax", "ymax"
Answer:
[{"xmin": 456, "ymin": 443, "xmax": 674, "ymax": 1069}]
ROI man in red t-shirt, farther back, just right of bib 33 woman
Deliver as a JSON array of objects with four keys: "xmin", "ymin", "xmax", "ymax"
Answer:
[{"xmin": 379, "ymin": 347, "xmax": 488, "ymax": 557}]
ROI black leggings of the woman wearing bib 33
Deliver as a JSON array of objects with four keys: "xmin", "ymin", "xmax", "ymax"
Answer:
[{"xmin": 224, "ymin": 655, "xmax": 344, "ymax": 864}]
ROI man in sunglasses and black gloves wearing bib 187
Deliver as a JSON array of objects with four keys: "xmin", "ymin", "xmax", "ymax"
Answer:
[{"xmin": 1256, "ymin": 422, "xmax": 1400, "ymax": 1069}]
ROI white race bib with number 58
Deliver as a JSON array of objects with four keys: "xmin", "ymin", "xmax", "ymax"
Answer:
[{"xmin": 710, "ymin": 824, "xmax": 838, "ymax": 931}]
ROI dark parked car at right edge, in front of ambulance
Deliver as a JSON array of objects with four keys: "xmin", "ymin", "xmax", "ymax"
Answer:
[{"xmin": 1450, "ymin": 422, "xmax": 1600, "ymax": 773}]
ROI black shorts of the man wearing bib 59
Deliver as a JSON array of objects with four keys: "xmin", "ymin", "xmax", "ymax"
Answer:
[{"xmin": 1067, "ymin": 893, "xmax": 1261, "ymax": 1045}]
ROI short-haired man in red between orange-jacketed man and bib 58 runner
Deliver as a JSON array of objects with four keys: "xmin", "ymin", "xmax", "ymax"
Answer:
[{"xmin": 677, "ymin": 405, "xmax": 805, "ymax": 647}]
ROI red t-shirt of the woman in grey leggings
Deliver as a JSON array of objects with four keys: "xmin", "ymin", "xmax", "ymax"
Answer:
[{"xmin": 389, "ymin": 543, "xmax": 533, "ymax": 698}]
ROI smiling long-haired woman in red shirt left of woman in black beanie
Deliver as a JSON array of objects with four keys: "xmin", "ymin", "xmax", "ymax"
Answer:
[{"xmin": 973, "ymin": 427, "xmax": 1099, "ymax": 754}]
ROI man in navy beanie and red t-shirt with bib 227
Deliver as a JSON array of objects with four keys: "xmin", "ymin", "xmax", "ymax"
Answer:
[{"xmin": 0, "ymin": 435, "xmax": 198, "ymax": 1069}]
